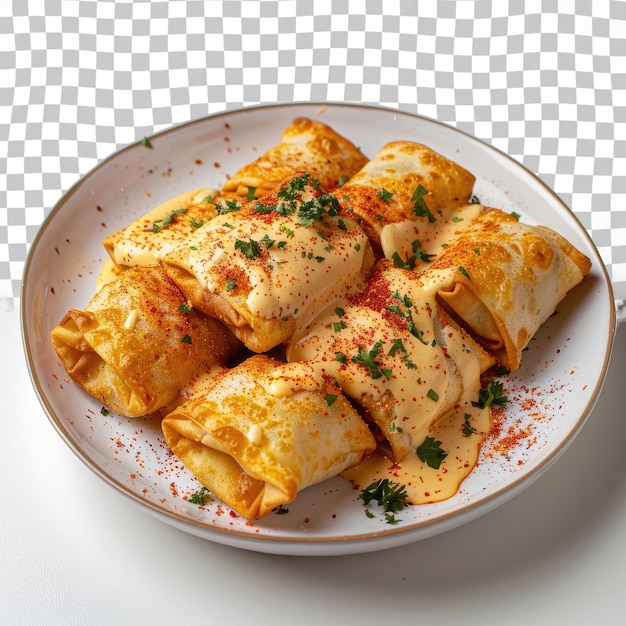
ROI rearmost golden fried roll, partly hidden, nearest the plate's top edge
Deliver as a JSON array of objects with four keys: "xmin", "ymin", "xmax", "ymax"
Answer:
[{"xmin": 222, "ymin": 117, "xmax": 367, "ymax": 199}]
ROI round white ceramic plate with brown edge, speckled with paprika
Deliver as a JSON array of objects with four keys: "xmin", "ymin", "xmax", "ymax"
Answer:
[{"xmin": 22, "ymin": 104, "xmax": 615, "ymax": 555}]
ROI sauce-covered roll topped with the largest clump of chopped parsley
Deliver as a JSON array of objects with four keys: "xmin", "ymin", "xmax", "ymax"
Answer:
[{"xmin": 163, "ymin": 174, "xmax": 374, "ymax": 352}]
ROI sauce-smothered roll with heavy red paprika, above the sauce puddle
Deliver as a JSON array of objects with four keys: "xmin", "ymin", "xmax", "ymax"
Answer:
[{"xmin": 286, "ymin": 259, "xmax": 494, "ymax": 462}]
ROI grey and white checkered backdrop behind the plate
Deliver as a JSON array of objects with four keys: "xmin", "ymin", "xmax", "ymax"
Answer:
[{"xmin": 0, "ymin": 0, "xmax": 626, "ymax": 309}]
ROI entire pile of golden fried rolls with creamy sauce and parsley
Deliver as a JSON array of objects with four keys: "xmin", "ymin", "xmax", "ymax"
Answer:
[{"xmin": 51, "ymin": 118, "xmax": 590, "ymax": 518}]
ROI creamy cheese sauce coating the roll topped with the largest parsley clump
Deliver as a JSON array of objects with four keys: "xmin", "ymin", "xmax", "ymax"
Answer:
[{"xmin": 187, "ymin": 199, "xmax": 371, "ymax": 330}]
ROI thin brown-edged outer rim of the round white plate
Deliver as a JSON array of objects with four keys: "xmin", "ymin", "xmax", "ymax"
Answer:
[{"xmin": 20, "ymin": 101, "xmax": 617, "ymax": 555}]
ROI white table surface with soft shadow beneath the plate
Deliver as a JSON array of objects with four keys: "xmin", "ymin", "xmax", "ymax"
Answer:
[{"xmin": 0, "ymin": 312, "xmax": 626, "ymax": 626}]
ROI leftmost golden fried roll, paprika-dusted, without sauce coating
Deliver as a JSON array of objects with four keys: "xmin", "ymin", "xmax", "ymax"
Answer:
[{"xmin": 51, "ymin": 266, "xmax": 240, "ymax": 417}]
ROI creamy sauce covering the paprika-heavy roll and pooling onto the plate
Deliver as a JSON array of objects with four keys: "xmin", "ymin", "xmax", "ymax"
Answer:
[{"xmin": 287, "ymin": 258, "xmax": 490, "ymax": 504}]
